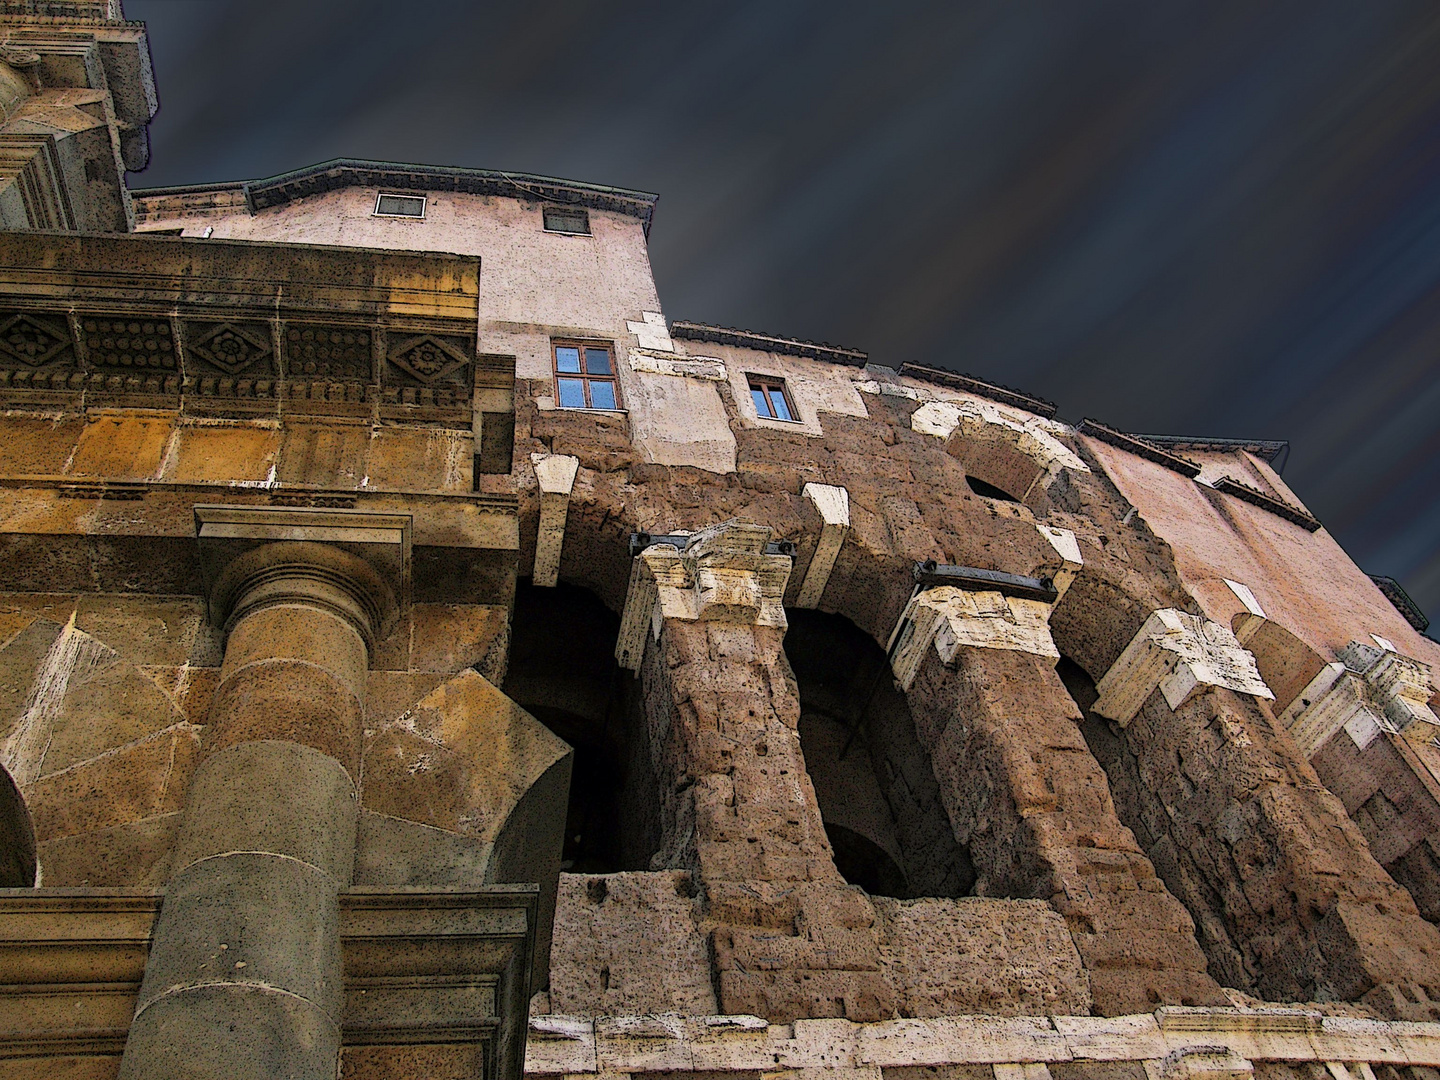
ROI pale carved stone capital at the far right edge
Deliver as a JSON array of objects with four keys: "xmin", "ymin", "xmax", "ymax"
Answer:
[{"xmin": 1280, "ymin": 641, "xmax": 1440, "ymax": 757}]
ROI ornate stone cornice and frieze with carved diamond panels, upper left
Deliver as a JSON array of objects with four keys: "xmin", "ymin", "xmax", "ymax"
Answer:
[{"xmin": 0, "ymin": 233, "xmax": 501, "ymax": 429}]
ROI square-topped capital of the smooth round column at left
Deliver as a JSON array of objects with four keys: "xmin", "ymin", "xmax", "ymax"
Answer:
[{"xmin": 194, "ymin": 505, "xmax": 410, "ymax": 647}]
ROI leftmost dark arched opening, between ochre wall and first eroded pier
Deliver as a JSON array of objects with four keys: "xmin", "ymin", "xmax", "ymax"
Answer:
[{"xmin": 503, "ymin": 580, "xmax": 660, "ymax": 874}]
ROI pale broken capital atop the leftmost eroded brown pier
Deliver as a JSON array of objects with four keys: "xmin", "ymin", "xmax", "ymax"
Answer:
[{"xmin": 615, "ymin": 520, "xmax": 792, "ymax": 671}]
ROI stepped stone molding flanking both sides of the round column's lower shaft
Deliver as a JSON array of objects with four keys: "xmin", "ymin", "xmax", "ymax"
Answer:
[{"xmin": 0, "ymin": 886, "xmax": 537, "ymax": 1080}]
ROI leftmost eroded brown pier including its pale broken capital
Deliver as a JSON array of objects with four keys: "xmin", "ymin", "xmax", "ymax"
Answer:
[{"xmin": 616, "ymin": 521, "xmax": 893, "ymax": 1022}]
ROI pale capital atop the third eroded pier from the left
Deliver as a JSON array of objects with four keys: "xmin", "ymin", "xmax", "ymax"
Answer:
[{"xmin": 1094, "ymin": 608, "xmax": 1274, "ymax": 727}]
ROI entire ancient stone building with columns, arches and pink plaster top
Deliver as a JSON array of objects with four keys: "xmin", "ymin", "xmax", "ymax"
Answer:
[{"xmin": 0, "ymin": 0, "xmax": 1440, "ymax": 1080}]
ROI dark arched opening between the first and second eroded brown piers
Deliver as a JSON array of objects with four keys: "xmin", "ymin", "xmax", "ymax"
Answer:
[{"xmin": 785, "ymin": 609, "xmax": 975, "ymax": 900}]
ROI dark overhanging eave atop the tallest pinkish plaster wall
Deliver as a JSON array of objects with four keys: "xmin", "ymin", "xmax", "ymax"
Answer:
[{"xmin": 131, "ymin": 157, "xmax": 660, "ymax": 236}]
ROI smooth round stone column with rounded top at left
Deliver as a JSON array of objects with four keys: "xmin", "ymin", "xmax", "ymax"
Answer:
[{"xmin": 121, "ymin": 533, "xmax": 396, "ymax": 1080}]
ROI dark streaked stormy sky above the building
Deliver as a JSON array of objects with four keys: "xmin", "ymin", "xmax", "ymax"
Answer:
[{"xmin": 125, "ymin": 0, "xmax": 1440, "ymax": 622}]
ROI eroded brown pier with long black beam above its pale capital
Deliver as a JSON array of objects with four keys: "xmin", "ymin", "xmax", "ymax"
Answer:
[{"xmin": 893, "ymin": 567, "xmax": 1225, "ymax": 1015}]
